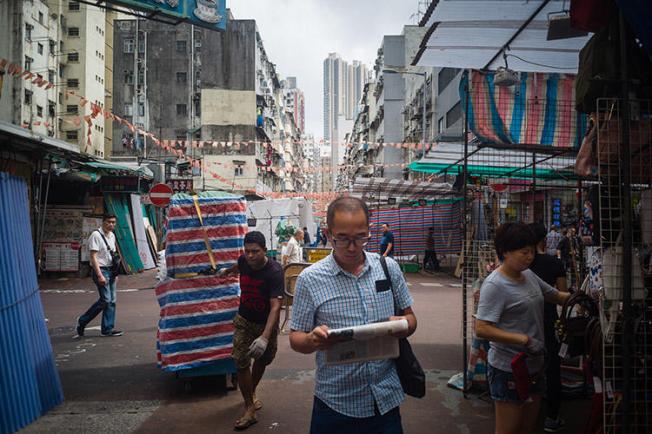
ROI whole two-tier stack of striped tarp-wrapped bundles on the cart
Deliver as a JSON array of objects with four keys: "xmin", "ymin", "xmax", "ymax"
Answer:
[{"xmin": 156, "ymin": 192, "xmax": 247, "ymax": 371}]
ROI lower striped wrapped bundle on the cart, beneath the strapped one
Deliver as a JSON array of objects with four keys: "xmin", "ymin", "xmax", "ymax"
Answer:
[{"xmin": 156, "ymin": 276, "xmax": 240, "ymax": 372}]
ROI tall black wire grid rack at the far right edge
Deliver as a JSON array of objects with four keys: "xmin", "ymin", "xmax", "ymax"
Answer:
[{"xmin": 596, "ymin": 99, "xmax": 652, "ymax": 433}]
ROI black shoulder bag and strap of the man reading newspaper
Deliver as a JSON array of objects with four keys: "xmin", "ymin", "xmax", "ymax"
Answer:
[{"xmin": 380, "ymin": 255, "xmax": 426, "ymax": 398}]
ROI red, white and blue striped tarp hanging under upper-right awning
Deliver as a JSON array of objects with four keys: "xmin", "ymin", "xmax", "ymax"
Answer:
[{"xmin": 460, "ymin": 71, "xmax": 587, "ymax": 148}]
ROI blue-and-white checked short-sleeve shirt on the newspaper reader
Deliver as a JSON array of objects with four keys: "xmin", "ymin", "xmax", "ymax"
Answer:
[{"xmin": 291, "ymin": 252, "xmax": 412, "ymax": 418}]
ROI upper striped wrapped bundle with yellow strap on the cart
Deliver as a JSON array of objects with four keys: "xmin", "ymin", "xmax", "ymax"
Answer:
[{"xmin": 165, "ymin": 192, "xmax": 247, "ymax": 276}]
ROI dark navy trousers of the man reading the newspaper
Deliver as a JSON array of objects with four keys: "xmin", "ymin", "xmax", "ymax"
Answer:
[{"xmin": 310, "ymin": 397, "xmax": 403, "ymax": 434}]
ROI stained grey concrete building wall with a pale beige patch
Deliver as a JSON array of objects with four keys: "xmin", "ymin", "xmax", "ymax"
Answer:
[{"xmin": 113, "ymin": 20, "xmax": 256, "ymax": 152}]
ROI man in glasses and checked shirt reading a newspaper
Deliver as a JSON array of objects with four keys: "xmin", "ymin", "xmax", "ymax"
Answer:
[{"xmin": 290, "ymin": 197, "xmax": 417, "ymax": 434}]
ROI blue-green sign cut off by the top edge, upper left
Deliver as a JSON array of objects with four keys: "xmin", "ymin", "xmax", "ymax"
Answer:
[{"xmin": 107, "ymin": 0, "xmax": 226, "ymax": 30}]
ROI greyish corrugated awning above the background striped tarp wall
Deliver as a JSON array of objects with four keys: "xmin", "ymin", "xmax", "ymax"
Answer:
[{"xmin": 351, "ymin": 178, "xmax": 453, "ymax": 203}]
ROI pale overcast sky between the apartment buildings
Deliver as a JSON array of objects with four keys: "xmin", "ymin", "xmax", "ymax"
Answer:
[{"xmin": 227, "ymin": 0, "xmax": 418, "ymax": 138}]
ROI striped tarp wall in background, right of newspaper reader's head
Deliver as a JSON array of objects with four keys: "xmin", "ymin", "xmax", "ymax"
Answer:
[{"xmin": 367, "ymin": 203, "xmax": 462, "ymax": 256}]
